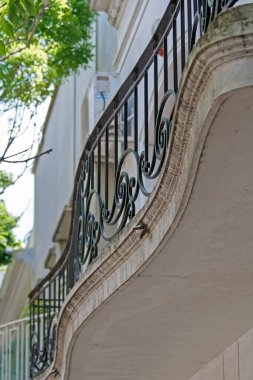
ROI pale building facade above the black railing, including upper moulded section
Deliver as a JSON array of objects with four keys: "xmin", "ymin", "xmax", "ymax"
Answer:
[{"xmin": 34, "ymin": 0, "xmax": 168, "ymax": 281}]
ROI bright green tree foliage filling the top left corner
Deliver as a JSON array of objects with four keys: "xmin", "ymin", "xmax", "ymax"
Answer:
[{"xmin": 0, "ymin": 0, "xmax": 94, "ymax": 106}]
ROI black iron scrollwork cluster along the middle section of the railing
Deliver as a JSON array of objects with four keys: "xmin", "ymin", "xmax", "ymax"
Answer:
[{"xmin": 74, "ymin": 90, "xmax": 175, "ymax": 270}]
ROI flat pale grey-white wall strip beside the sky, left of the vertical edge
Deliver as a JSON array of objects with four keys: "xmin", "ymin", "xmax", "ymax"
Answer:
[{"xmin": 34, "ymin": 78, "xmax": 74, "ymax": 279}]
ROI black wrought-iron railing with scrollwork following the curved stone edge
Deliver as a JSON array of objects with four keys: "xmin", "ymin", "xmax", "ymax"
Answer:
[{"xmin": 30, "ymin": 0, "xmax": 239, "ymax": 376}]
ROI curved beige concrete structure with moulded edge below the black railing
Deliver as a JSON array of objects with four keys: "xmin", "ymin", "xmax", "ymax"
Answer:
[{"xmin": 41, "ymin": 5, "xmax": 253, "ymax": 380}]
